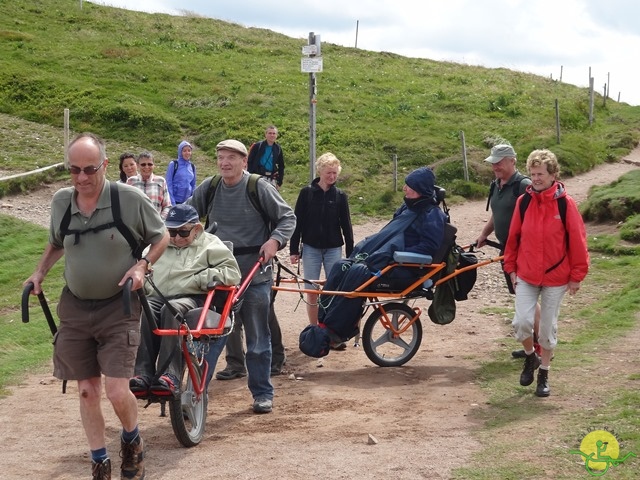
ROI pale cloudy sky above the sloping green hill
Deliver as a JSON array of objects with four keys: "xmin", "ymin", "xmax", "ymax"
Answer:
[{"xmin": 94, "ymin": 0, "xmax": 640, "ymax": 105}]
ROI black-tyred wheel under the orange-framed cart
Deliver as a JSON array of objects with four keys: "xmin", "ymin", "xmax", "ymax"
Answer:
[{"xmin": 362, "ymin": 303, "xmax": 422, "ymax": 367}]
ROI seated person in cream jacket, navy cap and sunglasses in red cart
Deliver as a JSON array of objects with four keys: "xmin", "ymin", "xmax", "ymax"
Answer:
[{"xmin": 129, "ymin": 204, "xmax": 241, "ymax": 394}]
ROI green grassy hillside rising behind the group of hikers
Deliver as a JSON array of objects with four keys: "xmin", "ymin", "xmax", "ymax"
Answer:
[{"xmin": 0, "ymin": 0, "xmax": 640, "ymax": 215}]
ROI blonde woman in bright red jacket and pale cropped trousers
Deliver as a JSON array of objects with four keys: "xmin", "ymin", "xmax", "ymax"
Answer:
[{"xmin": 504, "ymin": 150, "xmax": 589, "ymax": 397}]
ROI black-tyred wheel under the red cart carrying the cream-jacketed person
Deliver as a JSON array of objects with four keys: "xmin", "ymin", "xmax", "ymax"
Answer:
[{"xmin": 169, "ymin": 356, "xmax": 208, "ymax": 447}]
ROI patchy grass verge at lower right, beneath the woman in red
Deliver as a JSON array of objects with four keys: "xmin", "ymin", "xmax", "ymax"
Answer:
[{"xmin": 454, "ymin": 251, "xmax": 640, "ymax": 480}]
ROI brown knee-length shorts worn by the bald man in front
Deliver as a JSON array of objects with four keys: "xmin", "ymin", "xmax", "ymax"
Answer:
[{"xmin": 53, "ymin": 287, "xmax": 140, "ymax": 380}]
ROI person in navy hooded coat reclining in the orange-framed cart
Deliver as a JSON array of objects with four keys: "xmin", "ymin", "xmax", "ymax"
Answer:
[{"xmin": 300, "ymin": 167, "xmax": 448, "ymax": 357}]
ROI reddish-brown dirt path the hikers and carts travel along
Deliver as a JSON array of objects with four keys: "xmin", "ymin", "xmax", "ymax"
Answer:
[{"xmin": 0, "ymin": 155, "xmax": 640, "ymax": 480}]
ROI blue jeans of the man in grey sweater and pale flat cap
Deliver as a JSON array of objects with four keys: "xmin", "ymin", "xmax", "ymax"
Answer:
[{"xmin": 236, "ymin": 279, "xmax": 273, "ymax": 400}]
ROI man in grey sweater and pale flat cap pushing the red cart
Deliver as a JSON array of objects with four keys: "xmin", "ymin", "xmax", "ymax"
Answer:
[{"xmin": 189, "ymin": 140, "xmax": 296, "ymax": 413}]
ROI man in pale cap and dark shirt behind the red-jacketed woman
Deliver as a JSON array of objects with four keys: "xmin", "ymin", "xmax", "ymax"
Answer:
[{"xmin": 476, "ymin": 143, "xmax": 540, "ymax": 358}]
